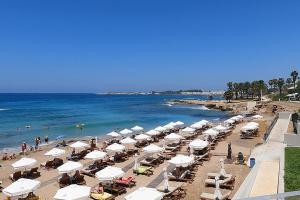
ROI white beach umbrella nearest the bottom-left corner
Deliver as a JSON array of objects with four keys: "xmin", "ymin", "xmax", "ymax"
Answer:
[{"xmin": 3, "ymin": 178, "xmax": 41, "ymax": 197}]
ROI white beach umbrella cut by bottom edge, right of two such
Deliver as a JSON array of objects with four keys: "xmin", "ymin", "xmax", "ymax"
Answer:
[{"xmin": 125, "ymin": 187, "xmax": 164, "ymax": 200}]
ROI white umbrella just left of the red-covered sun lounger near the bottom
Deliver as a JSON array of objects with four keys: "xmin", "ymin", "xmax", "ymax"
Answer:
[{"xmin": 96, "ymin": 166, "xmax": 125, "ymax": 181}]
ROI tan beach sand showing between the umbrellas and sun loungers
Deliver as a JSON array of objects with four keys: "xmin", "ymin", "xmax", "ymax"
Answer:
[{"xmin": 0, "ymin": 109, "xmax": 272, "ymax": 200}]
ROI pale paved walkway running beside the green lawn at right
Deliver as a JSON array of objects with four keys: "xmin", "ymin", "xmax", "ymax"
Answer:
[{"xmin": 233, "ymin": 113, "xmax": 290, "ymax": 199}]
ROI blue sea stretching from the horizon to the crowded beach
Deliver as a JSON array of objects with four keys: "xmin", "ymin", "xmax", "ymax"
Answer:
[{"xmin": 0, "ymin": 94, "xmax": 228, "ymax": 149}]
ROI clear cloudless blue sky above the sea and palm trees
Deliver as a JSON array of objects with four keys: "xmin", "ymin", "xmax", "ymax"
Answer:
[{"xmin": 0, "ymin": 0, "xmax": 300, "ymax": 92}]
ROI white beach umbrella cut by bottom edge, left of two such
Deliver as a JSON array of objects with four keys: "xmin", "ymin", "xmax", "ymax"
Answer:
[{"xmin": 54, "ymin": 184, "xmax": 91, "ymax": 200}]
